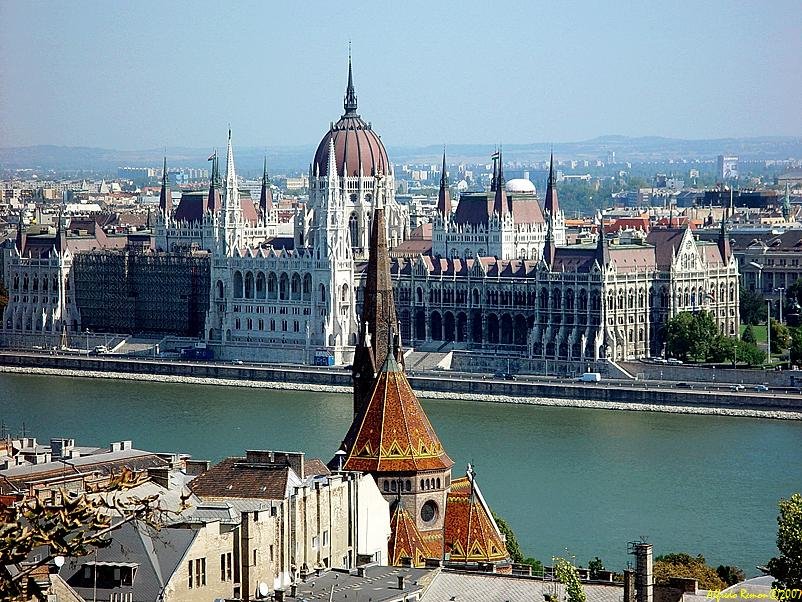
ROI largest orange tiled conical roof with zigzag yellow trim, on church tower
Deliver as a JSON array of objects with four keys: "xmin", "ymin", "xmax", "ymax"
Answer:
[{"xmin": 343, "ymin": 354, "xmax": 454, "ymax": 474}]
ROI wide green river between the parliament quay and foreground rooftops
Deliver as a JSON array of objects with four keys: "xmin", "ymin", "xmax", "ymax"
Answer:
[{"xmin": 0, "ymin": 374, "xmax": 802, "ymax": 575}]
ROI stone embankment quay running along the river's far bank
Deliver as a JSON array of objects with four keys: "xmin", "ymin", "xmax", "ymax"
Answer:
[{"xmin": 0, "ymin": 352, "xmax": 802, "ymax": 420}]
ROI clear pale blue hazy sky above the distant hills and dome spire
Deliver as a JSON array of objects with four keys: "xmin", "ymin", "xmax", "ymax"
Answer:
[{"xmin": 0, "ymin": 0, "xmax": 802, "ymax": 149}]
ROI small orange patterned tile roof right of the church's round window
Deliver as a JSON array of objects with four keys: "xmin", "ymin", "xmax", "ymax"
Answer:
[{"xmin": 445, "ymin": 476, "xmax": 508, "ymax": 562}]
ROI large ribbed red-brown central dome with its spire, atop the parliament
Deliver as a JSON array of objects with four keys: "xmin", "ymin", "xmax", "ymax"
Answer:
[{"xmin": 312, "ymin": 58, "xmax": 390, "ymax": 177}]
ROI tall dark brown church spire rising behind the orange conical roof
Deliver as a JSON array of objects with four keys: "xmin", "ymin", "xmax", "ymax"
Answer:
[{"xmin": 352, "ymin": 186, "xmax": 403, "ymax": 415}]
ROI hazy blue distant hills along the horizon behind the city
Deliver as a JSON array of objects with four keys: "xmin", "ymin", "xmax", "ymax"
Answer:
[{"xmin": 0, "ymin": 135, "xmax": 802, "ymax": 175}]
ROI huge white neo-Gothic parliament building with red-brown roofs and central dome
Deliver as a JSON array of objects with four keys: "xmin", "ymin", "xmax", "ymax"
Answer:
[{"xmin": 0, "ymin": 63, "xmax": 739, "ymax": 371}]
